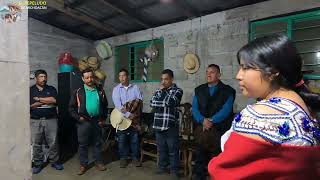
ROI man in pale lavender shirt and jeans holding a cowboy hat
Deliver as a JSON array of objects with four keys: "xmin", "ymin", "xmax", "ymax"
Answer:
[{"xmin": 112, "ymin": 69, "xmax": 142, "ymax": 168}]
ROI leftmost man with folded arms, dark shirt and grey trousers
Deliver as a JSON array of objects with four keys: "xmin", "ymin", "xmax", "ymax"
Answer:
[{"xmin": 30, "ymin": 70, "xmax": 63, "ymax": 174}]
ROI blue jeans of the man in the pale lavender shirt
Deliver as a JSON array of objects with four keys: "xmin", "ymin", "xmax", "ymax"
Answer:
[{"xmin": 117, "ymin": 127, "xmax": 140, "ymax": 160}]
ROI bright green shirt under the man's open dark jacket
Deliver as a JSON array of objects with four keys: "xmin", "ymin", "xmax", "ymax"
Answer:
[{"xmin": 83, "ymin": 84, "xmax": 100, "ymax": 117}]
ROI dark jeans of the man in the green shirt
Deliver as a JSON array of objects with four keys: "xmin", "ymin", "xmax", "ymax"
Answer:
[{"xmin": 78, "ymin": 119, "xmax": 102, "ymax": 166}]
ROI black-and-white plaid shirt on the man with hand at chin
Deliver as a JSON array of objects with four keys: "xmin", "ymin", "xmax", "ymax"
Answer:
[{"xmin": 150, "ymin": 84, "xmax": 183, "ymax": 131}]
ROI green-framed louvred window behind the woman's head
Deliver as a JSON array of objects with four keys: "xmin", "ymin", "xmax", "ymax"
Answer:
[{"xmin": 249, "ymin": 10, "xmax": 320, "ymax": 80}]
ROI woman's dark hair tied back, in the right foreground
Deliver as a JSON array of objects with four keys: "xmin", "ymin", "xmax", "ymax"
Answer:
[{"xmin": 237, "ymin": 34, "xmax": 320, "ymax": 112}]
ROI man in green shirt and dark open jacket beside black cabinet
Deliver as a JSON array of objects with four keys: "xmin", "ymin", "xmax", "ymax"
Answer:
[{"xmin": 69, "ymin": 69, "xmax": 108, "ymax": 175}]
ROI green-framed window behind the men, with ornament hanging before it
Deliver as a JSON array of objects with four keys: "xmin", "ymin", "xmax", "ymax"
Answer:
[{"xmin": 114, "ymin": 39, "xmax": 164, "ymax": 82}]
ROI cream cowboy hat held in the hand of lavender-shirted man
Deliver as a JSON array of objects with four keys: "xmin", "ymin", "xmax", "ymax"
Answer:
[{"xmin": 110, "ymin": 108, "xmax": 132, "ymax": 131}]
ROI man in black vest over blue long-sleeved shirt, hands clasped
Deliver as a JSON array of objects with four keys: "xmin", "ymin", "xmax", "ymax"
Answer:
[{"xmin": 192, "ymin": 64, "xmax": 235, "ymax": 180}]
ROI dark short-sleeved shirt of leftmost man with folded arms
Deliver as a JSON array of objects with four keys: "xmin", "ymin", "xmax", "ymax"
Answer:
[{"xmin": 30, "ymin": 85, "xmax": 58, "ymax": 119}]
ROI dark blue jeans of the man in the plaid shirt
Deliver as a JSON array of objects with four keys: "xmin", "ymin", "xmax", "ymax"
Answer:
[{"xmin": 155, "ymin": 127, "xmax": 179, "ymax": 173}]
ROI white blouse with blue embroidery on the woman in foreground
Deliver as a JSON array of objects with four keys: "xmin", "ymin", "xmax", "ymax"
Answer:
[{"xmin": 221, "ymin": 97, "xmax": 320, "ymax": 150}]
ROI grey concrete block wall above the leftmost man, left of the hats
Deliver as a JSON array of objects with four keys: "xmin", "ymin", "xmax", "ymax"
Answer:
[{"xmin": 29, "ymin": 19, "xmax": 94, "ymax": 87}]
